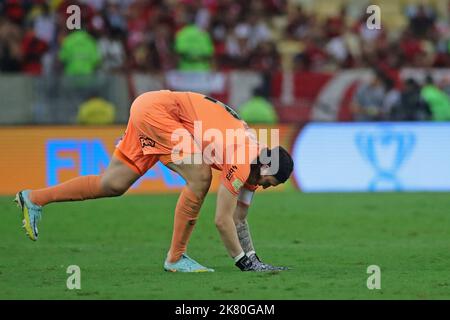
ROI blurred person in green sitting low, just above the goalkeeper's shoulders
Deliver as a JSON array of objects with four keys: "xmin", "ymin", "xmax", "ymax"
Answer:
[{"xmin": 239, "ymin": 88, "xmax": 278, "ymax": 124}]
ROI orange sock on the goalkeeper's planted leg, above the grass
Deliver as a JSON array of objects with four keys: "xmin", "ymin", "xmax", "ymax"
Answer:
[{"xmin": 168, "ymin": 186, "xmax": 203, "ymax": 262}]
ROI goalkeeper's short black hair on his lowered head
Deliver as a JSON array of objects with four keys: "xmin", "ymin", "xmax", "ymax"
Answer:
[{"xmin": 251, "ymin": 146, "xmax": 294, "ymax": 183}]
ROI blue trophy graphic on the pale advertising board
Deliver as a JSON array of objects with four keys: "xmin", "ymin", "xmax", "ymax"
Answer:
[{"xmin": 355, "ymin": 130, "xmax": 416, "ymax": 191}]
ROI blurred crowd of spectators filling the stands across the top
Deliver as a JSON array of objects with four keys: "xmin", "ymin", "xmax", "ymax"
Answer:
[{"xmin": 0, "ymin": 0, "xmax": 450, "ymax": 120}]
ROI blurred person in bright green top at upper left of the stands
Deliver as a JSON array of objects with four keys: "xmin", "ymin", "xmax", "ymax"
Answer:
[{"xmin": 59, "ymin": 30, "xmax": 101, "ymax": 76}]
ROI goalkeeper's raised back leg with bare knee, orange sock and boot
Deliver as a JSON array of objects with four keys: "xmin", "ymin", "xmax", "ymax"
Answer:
[{"xmin": 15, "ymin": 156, "xmax": 140, "ymax": 241}]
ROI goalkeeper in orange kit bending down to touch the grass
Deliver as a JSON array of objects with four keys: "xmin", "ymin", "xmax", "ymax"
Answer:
[{"xmin": 16, "ymin": 90, "xmax": 293, "ymax": 272}]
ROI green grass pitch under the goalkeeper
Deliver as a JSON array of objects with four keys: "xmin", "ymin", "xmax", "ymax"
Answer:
[{"xmin": 0, "ymin": 192, "xmax": 450, "ymax": 300}]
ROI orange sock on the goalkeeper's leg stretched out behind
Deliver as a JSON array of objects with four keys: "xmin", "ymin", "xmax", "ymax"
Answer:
[{"xmin": 30, "ymin": 175, "xmax": 106, "ymax": 206}]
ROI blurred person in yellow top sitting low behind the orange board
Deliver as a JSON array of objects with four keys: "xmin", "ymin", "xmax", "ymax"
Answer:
[{"xmin": 77, "ymin": 95, "xmax": 116, "ymax": 125}]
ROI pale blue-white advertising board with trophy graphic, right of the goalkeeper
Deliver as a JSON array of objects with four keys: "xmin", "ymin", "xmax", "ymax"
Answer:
[{"xmin": 292, "ymin": 122, "xmax": 450, "ymax": 192}]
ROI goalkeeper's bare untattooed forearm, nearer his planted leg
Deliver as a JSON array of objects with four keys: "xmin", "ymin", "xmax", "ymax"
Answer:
[{"xmin": 215, "ymin": 185, "xmax": 243, "ymax": 257}]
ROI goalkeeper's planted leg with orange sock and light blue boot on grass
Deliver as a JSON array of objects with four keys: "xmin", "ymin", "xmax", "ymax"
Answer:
[{"xmin": 164, "ymin": 163, "xmax": 214, "ymax": 272}]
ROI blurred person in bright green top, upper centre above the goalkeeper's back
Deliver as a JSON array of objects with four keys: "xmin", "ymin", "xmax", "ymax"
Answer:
[{"xmin": 175, "ymin": 24, "xmax": 214, "ymax": 71}]
